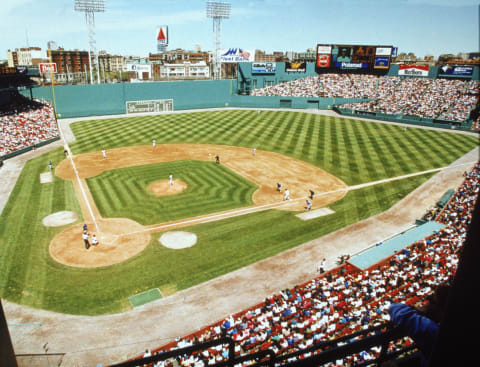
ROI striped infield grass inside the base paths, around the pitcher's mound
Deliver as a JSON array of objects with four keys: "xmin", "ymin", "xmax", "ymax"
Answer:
[{"xmin": 87, "ymin": 160, "xmax": 258, "ymax": 225}]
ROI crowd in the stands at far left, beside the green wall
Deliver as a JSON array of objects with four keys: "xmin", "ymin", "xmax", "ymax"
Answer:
[{"xmin": 0, "ymin": 100, "xmax": 59, "ymax": 156}]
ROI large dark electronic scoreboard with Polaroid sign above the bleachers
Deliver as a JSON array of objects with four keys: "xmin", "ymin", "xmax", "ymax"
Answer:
[{"xmin": 315, "ymin": 44, "xmax": 393, "ymax": 72}]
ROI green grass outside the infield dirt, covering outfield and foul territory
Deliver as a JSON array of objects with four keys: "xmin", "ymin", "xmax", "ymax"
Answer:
[{"xmin": 0, "ymin": 111, "xmax": 478, "ymax": 315}]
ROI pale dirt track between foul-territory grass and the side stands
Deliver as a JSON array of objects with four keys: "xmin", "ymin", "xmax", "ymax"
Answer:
[{"xmin": 0, "ymin": 110, "xmax": 479, "ymax": 366}]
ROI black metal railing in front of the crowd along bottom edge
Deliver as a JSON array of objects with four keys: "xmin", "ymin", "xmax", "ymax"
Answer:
[{"xmin": 110, "ymin": 323, "xmax": 417, "ymax": 367}]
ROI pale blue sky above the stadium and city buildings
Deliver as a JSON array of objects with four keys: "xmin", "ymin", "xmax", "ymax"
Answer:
[{"xmin": 0, "ymin": 0, "xmax": 480, "ymax": 59}]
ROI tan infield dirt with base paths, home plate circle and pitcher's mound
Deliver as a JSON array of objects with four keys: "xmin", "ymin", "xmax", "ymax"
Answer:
[{"xmin": 50, "ymin": 144, "xmax": 347, "ymax": 267}]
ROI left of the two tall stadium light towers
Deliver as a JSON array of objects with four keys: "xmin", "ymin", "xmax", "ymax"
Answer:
[{"xmin": 75, "ymin": 0, "xmax": 105, "ymax": 84}]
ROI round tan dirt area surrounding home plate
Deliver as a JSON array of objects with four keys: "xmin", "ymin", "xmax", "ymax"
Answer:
[{"xmin": 49, "ymin": 218, "xmax": 150, "ymax": 268}]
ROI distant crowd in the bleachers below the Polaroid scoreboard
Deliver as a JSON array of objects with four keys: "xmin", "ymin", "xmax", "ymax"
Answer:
[{"xmin": 252, "ymin": 74, "xmax": 480, "ymax": 122}]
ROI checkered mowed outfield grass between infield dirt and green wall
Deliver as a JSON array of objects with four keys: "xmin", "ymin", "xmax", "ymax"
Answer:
[{"xmin": 71, "ymin": 110, "xmax": 478, "ymax": 185}]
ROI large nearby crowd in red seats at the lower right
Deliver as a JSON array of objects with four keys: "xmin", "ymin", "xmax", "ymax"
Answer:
[{"xmin": 135, "ymin": 162, "xmax": 480, "ymax": 367}]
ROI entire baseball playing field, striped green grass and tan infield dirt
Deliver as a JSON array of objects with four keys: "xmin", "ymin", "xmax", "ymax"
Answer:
[{"xmin": 0, "ymin": 110, "xmax": 478, "ymax": 315}]
